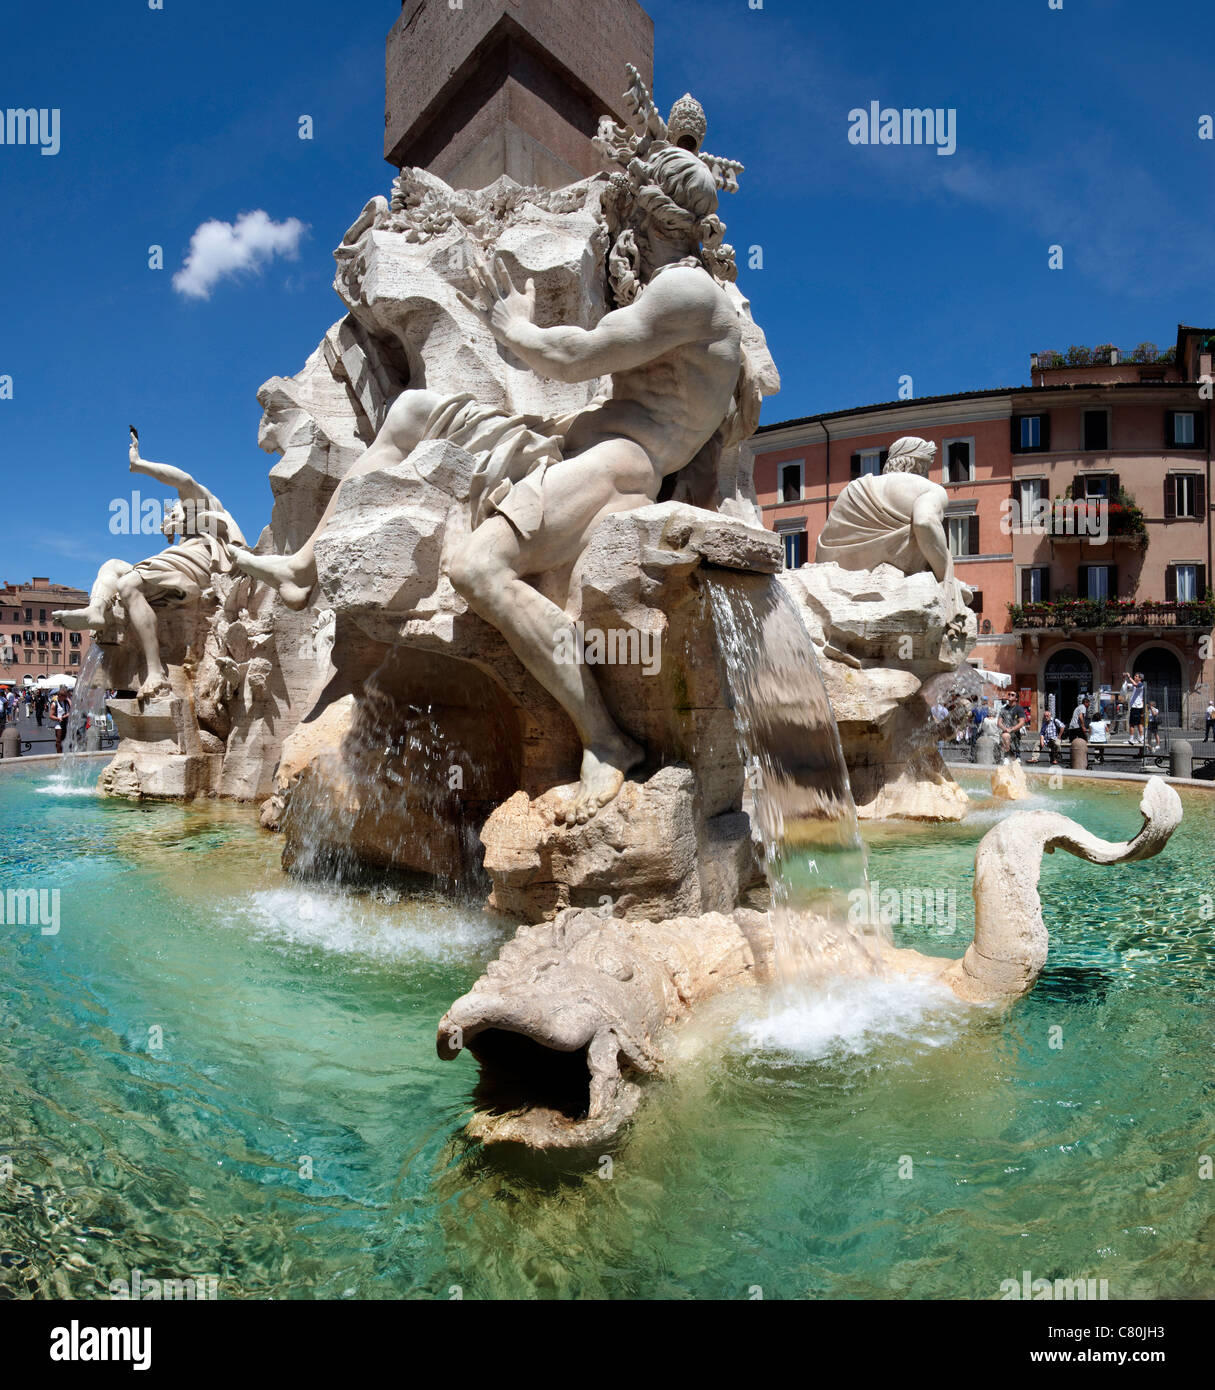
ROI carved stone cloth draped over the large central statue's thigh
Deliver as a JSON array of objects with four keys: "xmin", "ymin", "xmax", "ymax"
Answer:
[{"xmin": 423, "ymin": 393, "xmax": 576, "ymax": 541}]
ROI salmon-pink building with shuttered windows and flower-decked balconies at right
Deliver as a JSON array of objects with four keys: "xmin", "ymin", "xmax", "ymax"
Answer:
[{"xmin": 749, "ymin": 325, "xmax": 1215, "ymax": 728}]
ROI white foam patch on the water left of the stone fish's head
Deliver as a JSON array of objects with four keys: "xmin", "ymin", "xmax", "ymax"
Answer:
[{"xmin": 220, "ymin": 884, "xmax": 500, "ymax": 962}]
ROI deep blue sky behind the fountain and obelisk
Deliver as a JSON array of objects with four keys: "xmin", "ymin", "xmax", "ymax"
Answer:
[{"xmin": 0, "ymin": 0, "xmax": 1215, "ymax": 587}]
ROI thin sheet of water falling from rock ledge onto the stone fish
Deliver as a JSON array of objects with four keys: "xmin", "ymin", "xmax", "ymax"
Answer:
[{"xmin": 695, "ymin": 571, "xmax": 890, "ymax": 991}]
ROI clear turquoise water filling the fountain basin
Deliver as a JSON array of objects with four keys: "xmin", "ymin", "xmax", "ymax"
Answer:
[{"xmin": 0, "ymin": 767, "xmax": 1215, "ymax": 1298}]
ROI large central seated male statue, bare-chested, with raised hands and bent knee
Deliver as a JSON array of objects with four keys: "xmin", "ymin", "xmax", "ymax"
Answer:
[{"xmin": 235, "ymin": 135, "xmax": 742, "ymax": 823}]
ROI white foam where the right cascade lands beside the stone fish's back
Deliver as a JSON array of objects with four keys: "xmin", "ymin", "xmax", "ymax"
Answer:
[{"xmin": 738, "ymin": 974, "xmax": 969, "ymax": 1061}]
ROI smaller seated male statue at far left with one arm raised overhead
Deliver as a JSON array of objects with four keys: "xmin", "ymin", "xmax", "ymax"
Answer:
[{"xmin": 53, "ymin": 430, "xmax": 246, "ymax": 701}]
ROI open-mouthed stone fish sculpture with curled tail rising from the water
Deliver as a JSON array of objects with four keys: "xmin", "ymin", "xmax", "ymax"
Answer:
[{"xmin": 438, "ymin": 777, "xmax": 1182, "ymax": 1148}]
